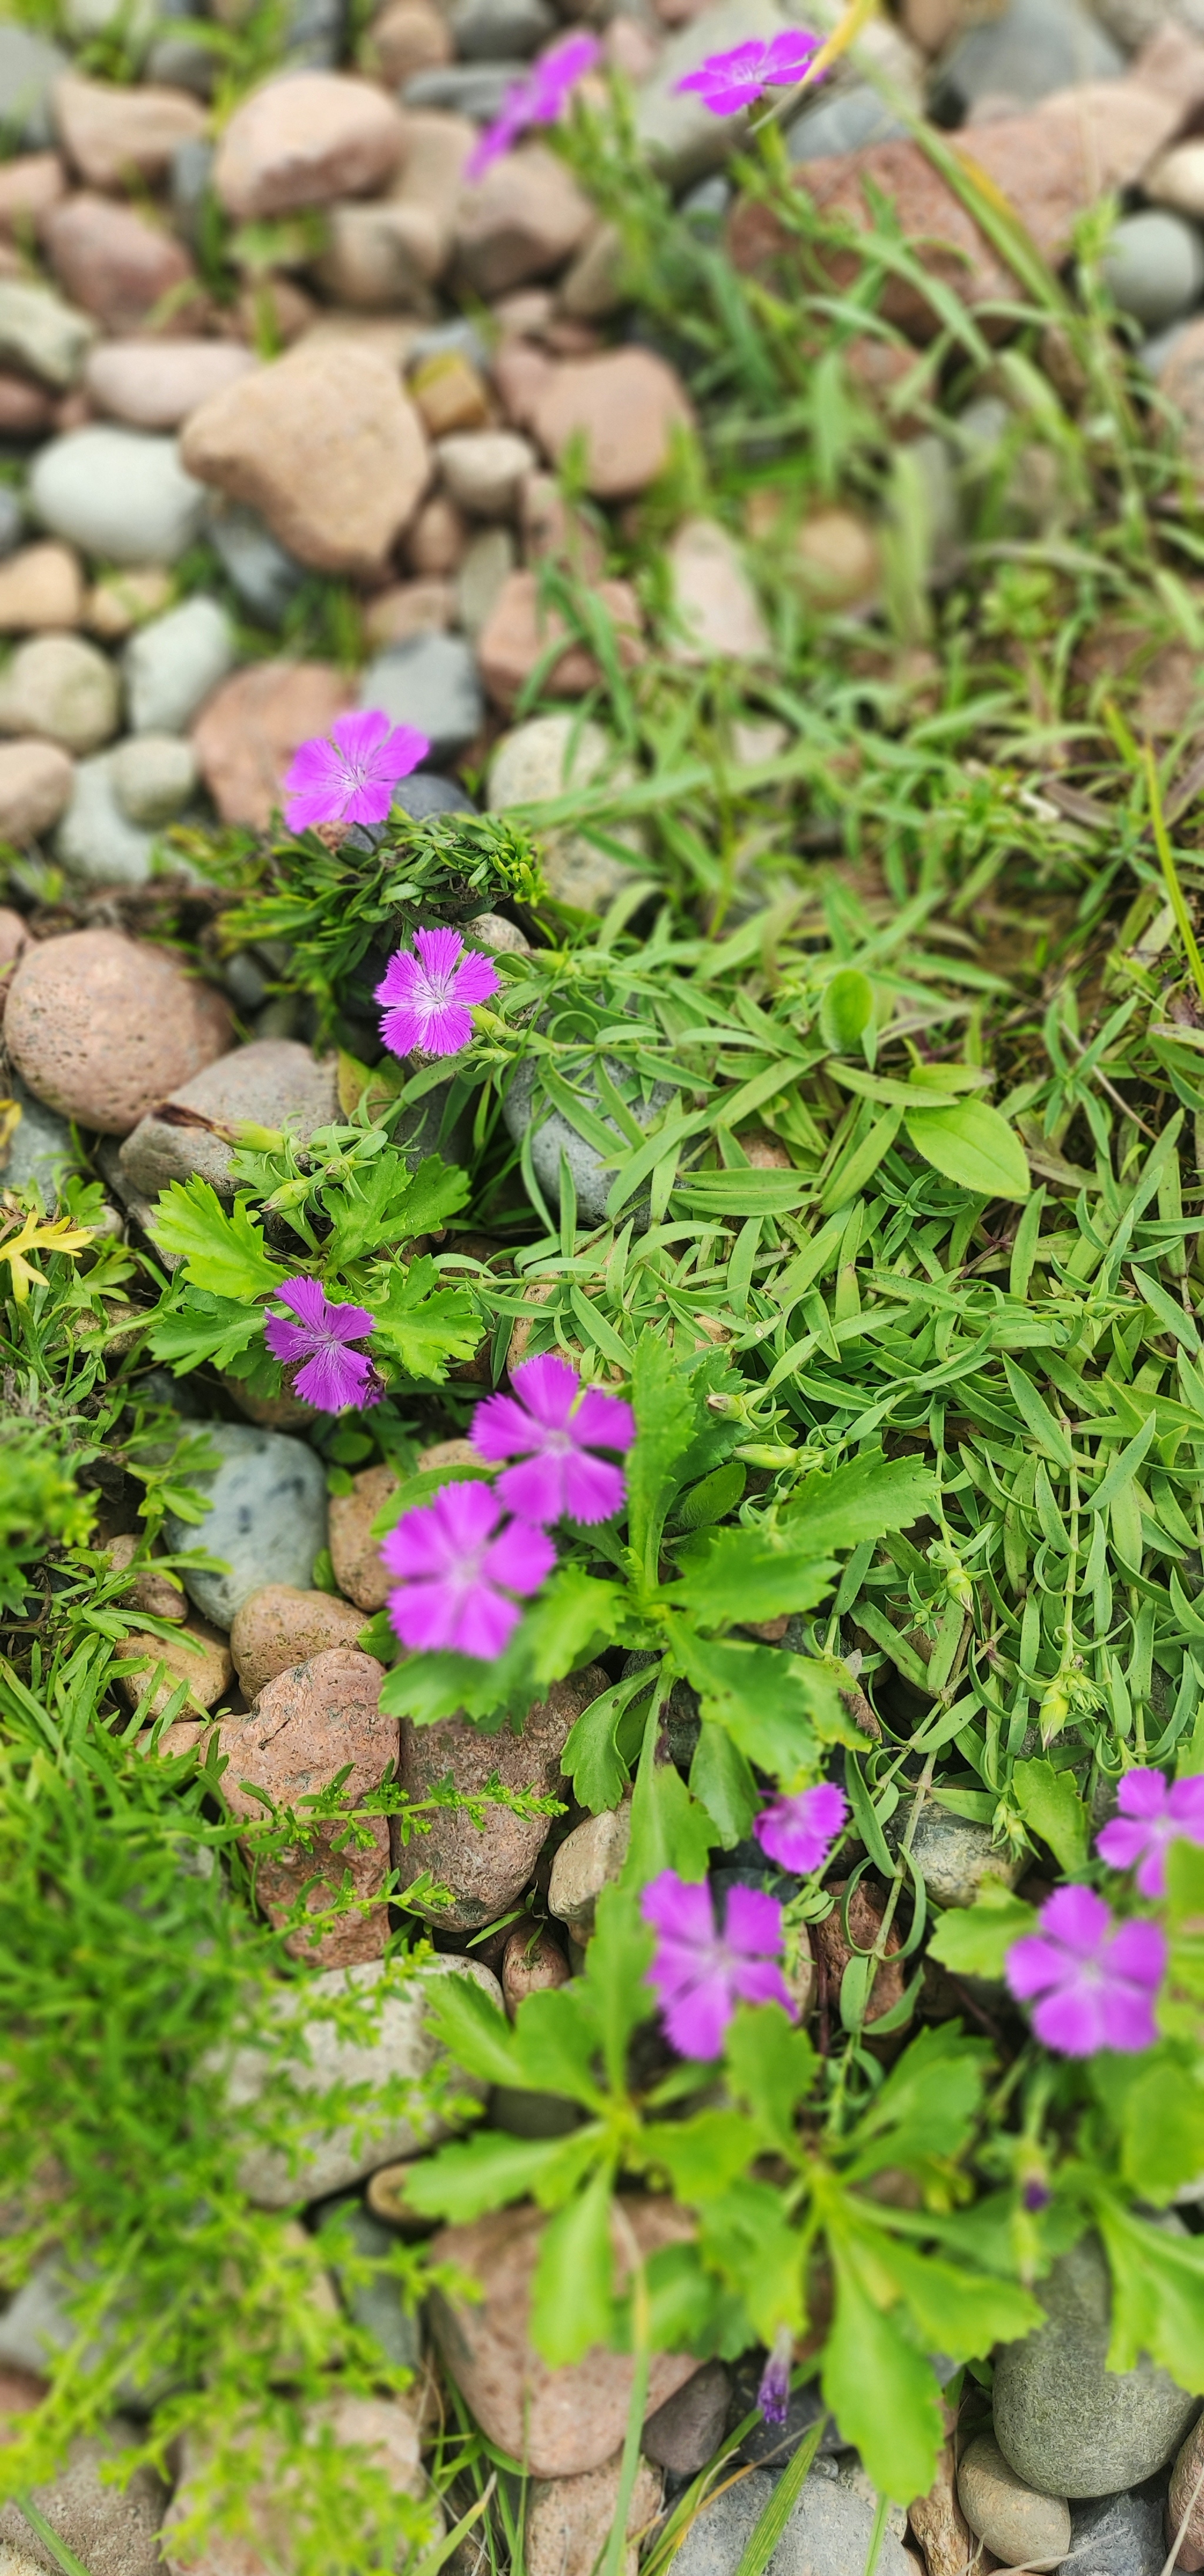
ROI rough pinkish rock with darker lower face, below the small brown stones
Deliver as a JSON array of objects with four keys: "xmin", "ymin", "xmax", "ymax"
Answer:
[{"xmin": 219, "ymin": 1646, "xmax": 397, "ymax": 1968}]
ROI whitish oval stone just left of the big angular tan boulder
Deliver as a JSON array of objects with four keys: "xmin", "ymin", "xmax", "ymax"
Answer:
[{"xmin": 28, "ymin": 425, "xmax": 203, "ymax": 564}]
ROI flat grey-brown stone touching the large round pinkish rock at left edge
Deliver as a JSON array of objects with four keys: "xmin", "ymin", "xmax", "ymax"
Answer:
[{"xmin": 119, "ymin": 1030, "xmax": 337, "ymax": 1200}]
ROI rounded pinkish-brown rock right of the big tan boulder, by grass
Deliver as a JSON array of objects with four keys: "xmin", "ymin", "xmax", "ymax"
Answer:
[{"xmin": 534, "ymin": 348, "xmax": 694, "ymax": 500}]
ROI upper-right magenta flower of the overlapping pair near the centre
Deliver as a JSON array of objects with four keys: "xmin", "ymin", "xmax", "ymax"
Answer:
[{"xmin": 472, "ymin": 1352, "xmax": 634, "ymax": 1522}]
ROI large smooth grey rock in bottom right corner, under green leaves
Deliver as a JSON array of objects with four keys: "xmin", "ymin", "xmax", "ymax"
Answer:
[{"xmin": 995, "ymin": 2236, "xmax": 1199, "ymax": 2499}]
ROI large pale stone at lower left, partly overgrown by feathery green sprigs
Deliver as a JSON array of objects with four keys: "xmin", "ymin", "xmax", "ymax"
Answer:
[{"xmin": 227, "ymin": 1950, "xmax": 503, "ymax": 2210}]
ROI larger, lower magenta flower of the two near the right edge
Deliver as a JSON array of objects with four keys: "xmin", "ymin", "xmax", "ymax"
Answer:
[{"xmin": 1005, "ymin": 1888, "xmax": 1165, "ymax": 2058}]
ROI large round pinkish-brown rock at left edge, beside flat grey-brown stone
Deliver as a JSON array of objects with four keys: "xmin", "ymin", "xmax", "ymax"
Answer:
[{"xmin": 5, "ymin": 930, "xmax": 232, "ymax": 1136}]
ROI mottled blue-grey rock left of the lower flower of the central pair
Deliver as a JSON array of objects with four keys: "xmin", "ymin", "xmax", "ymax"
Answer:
[{"xmin": 162, "ymin": 1422, "xmax": 335, "ymax": 1618}]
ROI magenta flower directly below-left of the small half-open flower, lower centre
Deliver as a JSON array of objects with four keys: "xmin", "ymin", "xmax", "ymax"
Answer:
[{"xmin": 640, "ymin": 1870, "xmax": 794, "ymax": 2058}]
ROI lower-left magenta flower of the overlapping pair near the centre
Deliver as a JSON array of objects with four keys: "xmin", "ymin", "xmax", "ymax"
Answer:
[{"xmin": 382, "ymin": 1481, "xmax": 557, "ymax": 1664}]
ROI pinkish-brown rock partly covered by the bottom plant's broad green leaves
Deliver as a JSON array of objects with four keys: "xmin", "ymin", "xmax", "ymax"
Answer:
[{"xmin": 430, "ymin": 2195, "xmax": 698, "ymax": 2478}]
